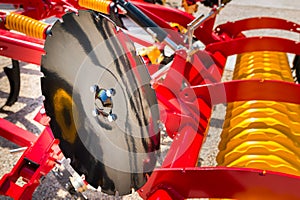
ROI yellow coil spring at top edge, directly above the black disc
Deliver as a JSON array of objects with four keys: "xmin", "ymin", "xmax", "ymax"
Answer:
[{"xmin": 78, "ymin": 0, "xmax": 112, "ymax": 14}]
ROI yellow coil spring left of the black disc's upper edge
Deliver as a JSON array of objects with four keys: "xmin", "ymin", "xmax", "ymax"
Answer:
[{"xmin": 5, "ymin": 13, "xmax": 49, "ymax": 39}]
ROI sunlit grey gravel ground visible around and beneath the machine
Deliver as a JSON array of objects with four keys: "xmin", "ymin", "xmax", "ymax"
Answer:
[{"xmin": 0, "ymin": 0, "xmax": 300, "ymax": 199}]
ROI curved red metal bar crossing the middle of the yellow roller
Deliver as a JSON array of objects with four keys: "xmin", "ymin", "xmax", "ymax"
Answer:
[{"xmin": 188, "ymin": 80, "xmax": 300, "ymax": 104}]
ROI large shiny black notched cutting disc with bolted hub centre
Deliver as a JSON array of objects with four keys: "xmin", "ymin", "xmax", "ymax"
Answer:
[{"xmin": 42, "ymin": 11, "xmax": 159, "ymax": 195}]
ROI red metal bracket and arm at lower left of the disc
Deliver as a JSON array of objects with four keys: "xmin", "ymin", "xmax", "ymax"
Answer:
[{"xmin": 0, "ymin": 124, "xmax": 62, "ymax": 200}]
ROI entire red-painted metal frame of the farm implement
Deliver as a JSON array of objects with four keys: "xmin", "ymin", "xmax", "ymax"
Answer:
[{"xmin": 0, "ymin": 0, "xmax": 300, "ymax": 199}]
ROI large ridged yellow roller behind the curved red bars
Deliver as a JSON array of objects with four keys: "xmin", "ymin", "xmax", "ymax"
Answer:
[{"xmin": 217, "ymin": 52, "xmax": 300, "ymax": 175}]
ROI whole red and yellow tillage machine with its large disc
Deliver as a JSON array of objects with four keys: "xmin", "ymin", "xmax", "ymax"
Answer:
[{"xmin": 0, "ymin": 0, "xmax": 300, "ymax": 199}]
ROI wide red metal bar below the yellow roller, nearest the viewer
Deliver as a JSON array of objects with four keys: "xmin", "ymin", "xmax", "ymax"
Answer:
[{"xmin": 139, "ymin": 167, "xmax": 300, "ymax": 200}]
